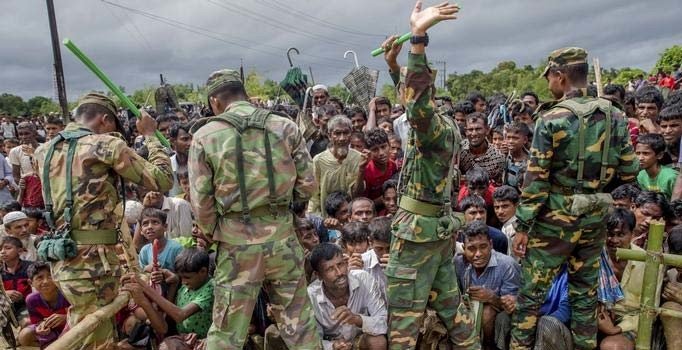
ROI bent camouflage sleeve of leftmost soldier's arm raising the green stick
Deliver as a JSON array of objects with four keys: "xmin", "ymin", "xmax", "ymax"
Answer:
[{"xmin": 106, "ymin": 137, "xmax": 173, "ymax": 192}]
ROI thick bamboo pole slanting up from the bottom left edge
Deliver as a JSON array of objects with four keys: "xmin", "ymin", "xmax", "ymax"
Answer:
[{"xmin": 46, "ymin": 292, "xmax": 130, "ymax": 350}]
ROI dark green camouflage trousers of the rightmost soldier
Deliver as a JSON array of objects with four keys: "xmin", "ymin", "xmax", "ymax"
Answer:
[{"xmin": 510, "ymin": 206, "xmax": 606, "ymax": 349}]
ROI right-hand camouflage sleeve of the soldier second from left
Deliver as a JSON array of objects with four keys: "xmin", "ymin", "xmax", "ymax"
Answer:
[{"xmin": 289, "ymin": 124, "xmax": 317, "ymax": 202}]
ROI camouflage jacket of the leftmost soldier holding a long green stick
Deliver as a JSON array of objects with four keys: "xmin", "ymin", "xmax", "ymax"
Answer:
[{"xmin": 35, "ymin": 122, "xmax": 173, "ymax": 230}]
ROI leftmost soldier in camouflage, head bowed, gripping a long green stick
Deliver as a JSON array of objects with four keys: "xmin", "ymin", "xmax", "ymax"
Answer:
[{"xmin": 35, "ymin": 93, "xmax": 173, "ymax": 349}]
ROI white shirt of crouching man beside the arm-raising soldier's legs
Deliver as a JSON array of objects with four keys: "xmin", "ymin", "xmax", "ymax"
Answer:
[{"xmin": 308, "ymin": 270, "xmax": 388, "ymax": 349}]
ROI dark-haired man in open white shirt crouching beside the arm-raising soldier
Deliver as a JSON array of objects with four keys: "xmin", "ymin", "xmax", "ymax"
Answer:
[{"xmin": 308, "ymin": 243, "xmax": 388, "ymax": 350}]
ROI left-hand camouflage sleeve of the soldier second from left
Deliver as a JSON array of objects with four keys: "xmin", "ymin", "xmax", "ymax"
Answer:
[{"xmin": 187, "ymin": 137, "xmax": 218, "ymax": 237}]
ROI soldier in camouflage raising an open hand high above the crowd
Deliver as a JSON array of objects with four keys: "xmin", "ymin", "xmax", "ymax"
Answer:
[{"xmin": 385, "ymin": 1, "xmax": 480, "ymax": 349}]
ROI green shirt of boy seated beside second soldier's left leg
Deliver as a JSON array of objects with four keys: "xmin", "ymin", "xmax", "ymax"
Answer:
[{"xmin": 175, "ymin": 279, "xmax": 213, "ymax": 339}]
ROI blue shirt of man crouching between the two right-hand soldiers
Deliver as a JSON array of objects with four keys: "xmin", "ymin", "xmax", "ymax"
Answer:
[{"xmin": 454, "ymin": 250, "xmax": 521, "ymax": 296}]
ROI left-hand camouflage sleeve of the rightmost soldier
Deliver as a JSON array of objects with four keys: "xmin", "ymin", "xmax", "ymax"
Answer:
[{"xmin": 516, "ymin": 118, "xmax": 554, "ymax": 233}]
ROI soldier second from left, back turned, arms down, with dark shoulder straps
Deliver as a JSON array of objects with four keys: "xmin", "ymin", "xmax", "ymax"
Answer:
[{"xmin": 188, "ymin": 70, "xmax": 321, "ymax": 349}]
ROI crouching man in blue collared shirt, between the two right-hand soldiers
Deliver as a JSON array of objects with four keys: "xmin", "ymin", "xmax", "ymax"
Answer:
[{"xmin": 454, "ymin": 220, "xmax": 521, "ymax": 350}]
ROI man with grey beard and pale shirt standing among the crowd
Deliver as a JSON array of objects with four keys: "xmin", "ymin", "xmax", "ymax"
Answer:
[{"xmin": 310, "ymin": 115, "xmax": 369, "ymax": 214}]
